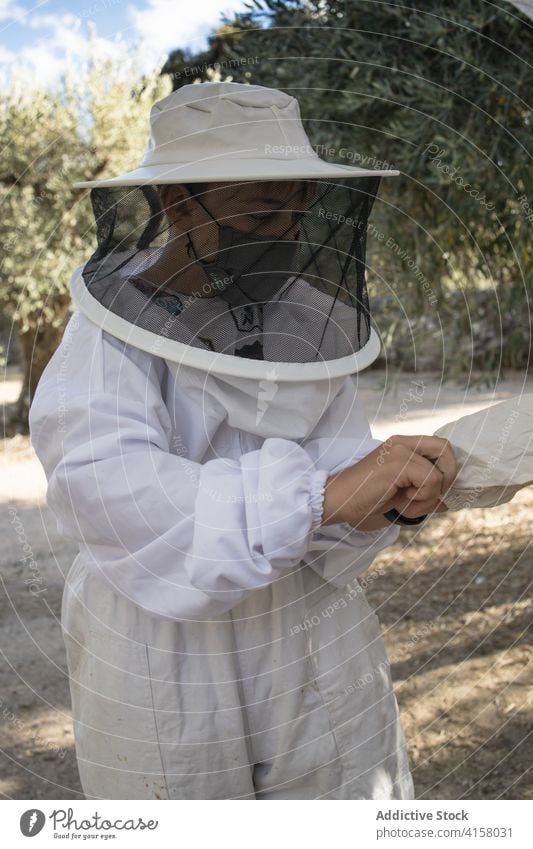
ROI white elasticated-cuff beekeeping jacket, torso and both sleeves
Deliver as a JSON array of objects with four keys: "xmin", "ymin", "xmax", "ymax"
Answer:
[{"xmin": 30, "ymin": 312, "xmax": 399, "ymax": 619}]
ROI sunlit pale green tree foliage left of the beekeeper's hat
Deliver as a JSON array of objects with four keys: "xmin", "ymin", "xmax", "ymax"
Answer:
[{"xmin": 0, "ymin": 44, "xmax": 170, "ymax": 422}]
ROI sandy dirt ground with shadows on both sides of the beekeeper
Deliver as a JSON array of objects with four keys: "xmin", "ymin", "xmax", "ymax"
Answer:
[{"xmin": 0, "ymin": 370, "xmax": 533, "ymax": 799}]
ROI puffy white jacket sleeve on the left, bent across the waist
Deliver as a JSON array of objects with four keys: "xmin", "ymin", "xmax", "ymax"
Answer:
[{"xmin": 30, "ymin": 314, "xmax": 326, "ymax": 620}]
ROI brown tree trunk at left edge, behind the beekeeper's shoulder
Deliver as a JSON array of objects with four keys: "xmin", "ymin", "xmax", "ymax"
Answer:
[{"xmin": 10, "ymin": 301, "xmax": 69, "ymax": 433}]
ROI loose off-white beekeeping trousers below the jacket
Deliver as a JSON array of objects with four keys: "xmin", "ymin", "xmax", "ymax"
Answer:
[{"xmin": 62, "ymin": 555, "xmax": 414, "ymax": 799}]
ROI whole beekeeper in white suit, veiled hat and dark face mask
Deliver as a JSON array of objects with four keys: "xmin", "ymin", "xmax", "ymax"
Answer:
[{"xmin": 30, "ymin": 83, "xmax": 455, "ymax": 799}]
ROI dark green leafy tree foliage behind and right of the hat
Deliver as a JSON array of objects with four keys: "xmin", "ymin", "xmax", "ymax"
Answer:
[{"xmin": 166, "ymin": 0, "xmax": 533, "ymax": 372}]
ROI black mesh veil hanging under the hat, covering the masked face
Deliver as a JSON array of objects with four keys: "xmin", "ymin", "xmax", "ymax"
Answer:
[{"xmin": 82, "ymin": 177, "xmax": 380, "ymax": 363}]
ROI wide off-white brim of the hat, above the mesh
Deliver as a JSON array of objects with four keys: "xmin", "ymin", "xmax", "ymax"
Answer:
[{"xmin": 74, "ymin": 157, "xmax": 400, "ymax": 189}]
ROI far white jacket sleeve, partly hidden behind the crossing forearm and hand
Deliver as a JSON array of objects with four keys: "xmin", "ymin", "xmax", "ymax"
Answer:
[{"xmin": 302, "ymin": 377, "xmax": 400, "ymax": 587}]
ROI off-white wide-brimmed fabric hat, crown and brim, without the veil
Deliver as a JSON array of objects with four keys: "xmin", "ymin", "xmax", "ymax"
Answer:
[{"xmin": 74, "ymin": 82, "xmax": 400, "ymax": 188}]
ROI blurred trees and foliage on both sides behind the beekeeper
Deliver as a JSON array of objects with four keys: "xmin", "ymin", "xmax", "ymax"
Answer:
[{"xmin": 0, "ymin": 0, "xmax": 533, "ymax": 429}]
